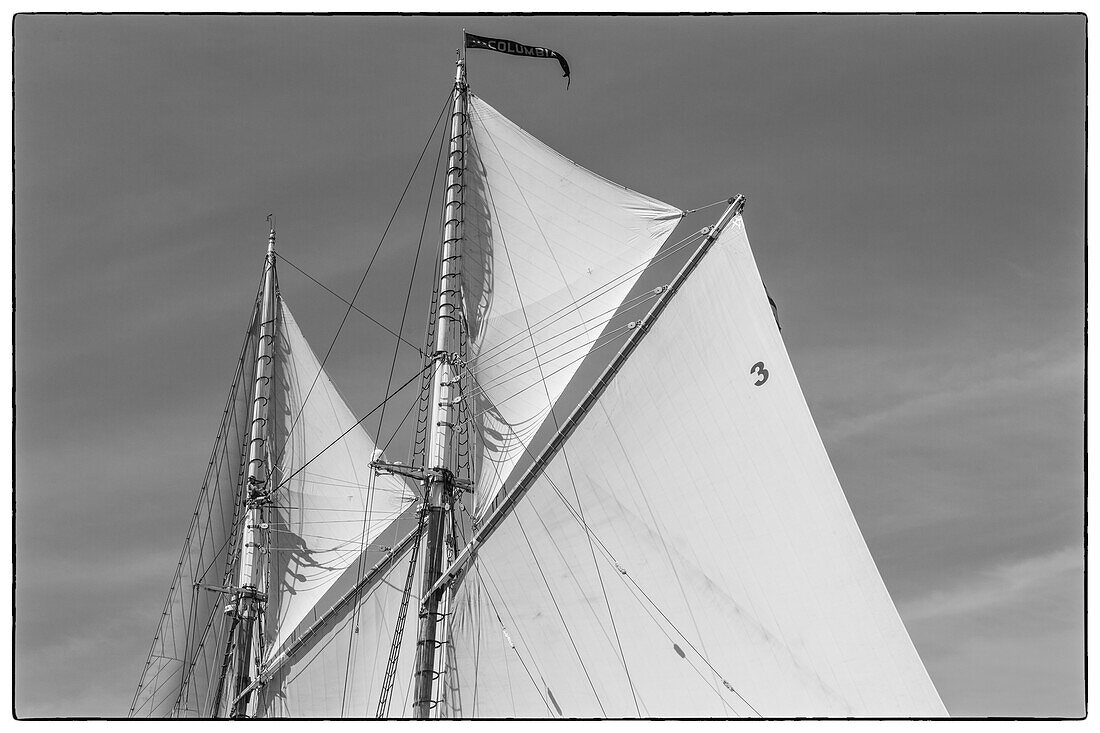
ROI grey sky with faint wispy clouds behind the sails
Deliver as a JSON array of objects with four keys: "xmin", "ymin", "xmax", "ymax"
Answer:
[{"xmin": 14, "ymin": 15, "xmax": 1086, "ymax": 718}]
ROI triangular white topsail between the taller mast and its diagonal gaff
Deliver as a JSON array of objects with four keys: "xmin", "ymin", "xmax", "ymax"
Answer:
[{"xmin": 462, "ymin": 95, "xmax": 681, "ymax": 514}]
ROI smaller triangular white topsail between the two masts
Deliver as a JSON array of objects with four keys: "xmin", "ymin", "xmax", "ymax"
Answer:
[{"xmin": 267, "ymin": 299, "xmax": 414, "ymax": 654}]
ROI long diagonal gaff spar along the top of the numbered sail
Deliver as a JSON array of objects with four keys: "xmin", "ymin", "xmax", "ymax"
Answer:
[{"xmin": 431, "ymin": 194, "xmax": 745, "ymax": 591}]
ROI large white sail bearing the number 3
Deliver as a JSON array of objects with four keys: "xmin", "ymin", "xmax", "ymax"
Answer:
[{"xmin": 448, "ymin": 218, "xmax": 946, "ymax": 718}]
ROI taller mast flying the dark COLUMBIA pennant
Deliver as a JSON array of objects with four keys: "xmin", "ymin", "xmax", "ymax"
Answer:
[{"xmin": 413, "ymin": 53, "xmax": 466, "ymax": 719}]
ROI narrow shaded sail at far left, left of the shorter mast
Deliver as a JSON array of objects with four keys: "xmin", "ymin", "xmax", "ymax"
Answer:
[{"xmin": 130, "ymin": 301, "xmax": 257, "ymax": 718}]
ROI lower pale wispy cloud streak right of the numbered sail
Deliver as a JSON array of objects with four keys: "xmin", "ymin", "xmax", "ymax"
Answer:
[{"xmin": 899, "ymin": 546, "xmax": 1085, "ymax": 622}]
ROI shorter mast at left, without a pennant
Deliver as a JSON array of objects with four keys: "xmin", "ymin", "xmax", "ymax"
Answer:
[{"xmin": 231, "ymin": 222, "xmax": 275, "ymax": 718}]
